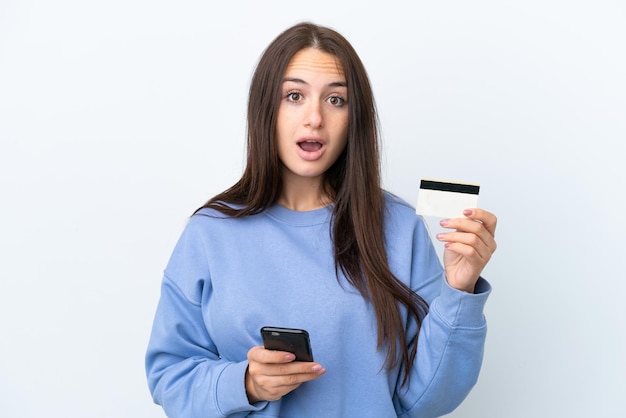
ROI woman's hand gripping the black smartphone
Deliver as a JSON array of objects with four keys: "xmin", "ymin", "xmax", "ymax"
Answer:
[{"xmin": 245, "ymin": 346, "xmax": 326, "ymax": 404}]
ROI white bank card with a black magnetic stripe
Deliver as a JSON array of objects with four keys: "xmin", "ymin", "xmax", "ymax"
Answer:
[{"xmin": 415, "ymin": 179, "xmax": 480, "ymax": 218}]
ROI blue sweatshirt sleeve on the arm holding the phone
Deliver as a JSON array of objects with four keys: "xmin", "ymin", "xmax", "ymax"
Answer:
[{"xmin": 146, "ymin": 220, "xmax": 265, "ymax": 418}]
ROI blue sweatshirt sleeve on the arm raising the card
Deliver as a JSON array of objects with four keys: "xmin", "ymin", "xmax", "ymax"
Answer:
[{"xmin": 395, "ymin": 216, "xmax": 491, "ymax": 418}]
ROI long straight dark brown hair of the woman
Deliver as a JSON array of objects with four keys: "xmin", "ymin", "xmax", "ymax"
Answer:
[{"xmin": 198, "ymin": 23, "xmax": 428, "ymax": 385}]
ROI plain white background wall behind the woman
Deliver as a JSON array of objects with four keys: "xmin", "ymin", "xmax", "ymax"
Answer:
[{"xmin": 0, "ymin": 0, "xmax": 626, "ymax": 418}]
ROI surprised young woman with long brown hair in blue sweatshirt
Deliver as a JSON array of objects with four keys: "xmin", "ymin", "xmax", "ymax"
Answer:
[{"xmin": 146, "ymin": 23, "xmax": 496, "ymax": 418}]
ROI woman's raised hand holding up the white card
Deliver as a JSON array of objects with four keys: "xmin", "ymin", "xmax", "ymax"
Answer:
[{"xmin": 437, "ymin": 209, "xmax": 497, "ymax": 293}]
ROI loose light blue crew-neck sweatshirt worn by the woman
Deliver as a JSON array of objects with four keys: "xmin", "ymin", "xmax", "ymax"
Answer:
[{"xmin": 146, "ymin": 194, "xmax": 491, "ymax": 418}]
